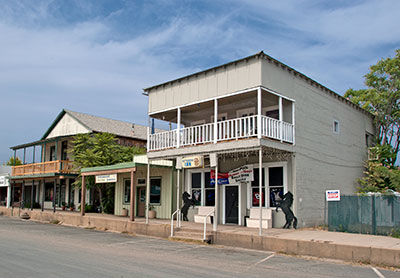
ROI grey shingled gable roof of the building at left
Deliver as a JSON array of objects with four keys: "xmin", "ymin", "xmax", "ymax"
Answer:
[{"xmin": 42, "ymin": 109, "xmax": 152, "ymax": 140}]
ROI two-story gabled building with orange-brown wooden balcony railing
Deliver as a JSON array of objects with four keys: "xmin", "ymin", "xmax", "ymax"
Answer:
[{"xmin": 10, "ymin": 109, "xmax": 147, "ymax": 209}]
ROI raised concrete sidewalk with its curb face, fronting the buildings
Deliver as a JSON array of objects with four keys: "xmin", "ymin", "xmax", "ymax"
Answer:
[{"xmin": 0, "ymin": 208, "xmax": 400, "ymax": 268}]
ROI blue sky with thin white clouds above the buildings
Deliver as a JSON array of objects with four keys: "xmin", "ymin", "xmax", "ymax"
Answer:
[{"xmin": 0, "ymin": 0, "xmax": 400, "ymax": 163}]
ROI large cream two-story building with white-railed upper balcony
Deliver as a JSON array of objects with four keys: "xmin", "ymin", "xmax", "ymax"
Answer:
[{"xmin": 144, "ymin": 52, "xmax": 374, "ymax": 230}]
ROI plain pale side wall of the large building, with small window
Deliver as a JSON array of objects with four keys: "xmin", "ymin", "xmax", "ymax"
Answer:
[{"xmin": 262, "ymin": 60, "xmax": 373, "ymax": 226}]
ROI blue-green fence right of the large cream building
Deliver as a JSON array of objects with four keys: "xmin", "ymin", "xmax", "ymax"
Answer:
[{"xmin": 327, "ymin": 195, "xmax": 400, "ymax": 235}]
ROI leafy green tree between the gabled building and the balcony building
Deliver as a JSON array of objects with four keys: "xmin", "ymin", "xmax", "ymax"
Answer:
[{"xmin": 72, "ymin": 133, "xmax": 146, "ymax": 212}]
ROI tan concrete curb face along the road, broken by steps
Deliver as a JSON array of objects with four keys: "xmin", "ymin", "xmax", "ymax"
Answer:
[{"xmin": 0, "ymin": 207, "xmax": 400, "ymax": 268}]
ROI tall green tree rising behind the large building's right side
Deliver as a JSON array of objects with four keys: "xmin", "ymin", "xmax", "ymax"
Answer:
[{"xmin": 344, "ymin": 49, "xmax": 400, "ymax": 166}]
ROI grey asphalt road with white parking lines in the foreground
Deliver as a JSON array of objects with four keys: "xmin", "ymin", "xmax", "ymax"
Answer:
[{"xmin": 0, "ymin": 216, "xmax": 400, "ymax": 278}]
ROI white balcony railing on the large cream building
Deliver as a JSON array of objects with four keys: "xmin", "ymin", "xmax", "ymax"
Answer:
[{"xmin": 148, "ymin": 115, "xmax": 294, "ymax": 151}]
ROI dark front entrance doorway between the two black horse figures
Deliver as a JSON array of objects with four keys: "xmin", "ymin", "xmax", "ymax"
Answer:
[{"xmin": 224, "ymin": 185, "xmax": 240, "ymax": 224}]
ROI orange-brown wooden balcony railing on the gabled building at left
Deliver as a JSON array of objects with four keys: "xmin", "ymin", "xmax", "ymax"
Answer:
[{"xmin": 12, "ymin": 160, "xmax": 75, "ymax": 176}]
